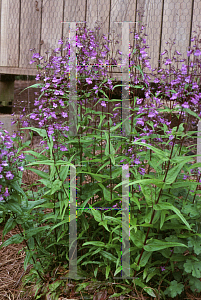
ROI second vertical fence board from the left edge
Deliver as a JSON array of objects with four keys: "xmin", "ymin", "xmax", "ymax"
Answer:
[{"xmin": 19, "ymin": 0, "xmax": 41, "ymax": 68}]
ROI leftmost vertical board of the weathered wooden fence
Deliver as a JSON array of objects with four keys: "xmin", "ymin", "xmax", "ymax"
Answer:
[{"xmin": 0, "ymin": 0, "xmax": 20, "ymax": 67}]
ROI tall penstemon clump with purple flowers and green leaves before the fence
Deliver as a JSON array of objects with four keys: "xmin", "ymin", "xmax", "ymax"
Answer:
[{"xmin": 1, "ymin": 17, "xmax": 201, "ymax": 299}]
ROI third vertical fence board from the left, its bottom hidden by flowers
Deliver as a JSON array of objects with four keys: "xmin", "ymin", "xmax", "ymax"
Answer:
[{"xmin": 40, "ymin": 0, "xmax": 63, "ymax": 56}]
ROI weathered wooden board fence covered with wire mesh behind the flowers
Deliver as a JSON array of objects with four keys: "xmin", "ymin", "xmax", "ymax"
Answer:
[{"xmin": 0, "ymin": 0, "xmax": 201, "ymax": 75}]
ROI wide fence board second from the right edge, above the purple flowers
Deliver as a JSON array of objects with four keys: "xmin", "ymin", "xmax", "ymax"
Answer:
[{"xmin": 161, "ymin": 0, "xmax": 192, "ymax": 64}]
